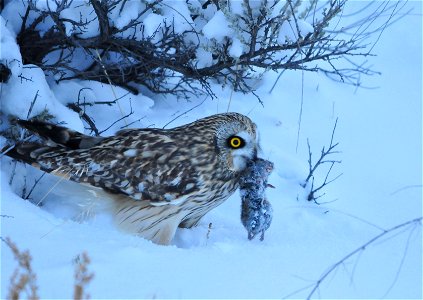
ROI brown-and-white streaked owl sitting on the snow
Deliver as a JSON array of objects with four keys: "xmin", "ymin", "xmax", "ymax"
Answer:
[{"xmin": 8, "ymin": 113, "xmax": 258, "ymax": 244}]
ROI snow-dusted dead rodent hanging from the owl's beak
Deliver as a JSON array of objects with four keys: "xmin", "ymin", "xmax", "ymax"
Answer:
[{"xmin": 239, "ymin": 158, "xmax": 273, "ymax": 241}]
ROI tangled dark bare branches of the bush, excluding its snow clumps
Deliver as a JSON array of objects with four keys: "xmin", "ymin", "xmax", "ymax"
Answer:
[{"xmin": 12, "ymin": 0, "xmax": 403, "ymax": 98}]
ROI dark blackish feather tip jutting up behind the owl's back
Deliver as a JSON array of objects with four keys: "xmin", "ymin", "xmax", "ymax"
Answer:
[{"xmin": 17, "ymin": 120, "xmax": 104, "ymax": 149}]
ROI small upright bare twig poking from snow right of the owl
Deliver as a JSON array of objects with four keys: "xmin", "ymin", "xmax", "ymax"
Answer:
[{"xmin": 301, "ymin": 118, "xmax": 342, "ymax": 204}]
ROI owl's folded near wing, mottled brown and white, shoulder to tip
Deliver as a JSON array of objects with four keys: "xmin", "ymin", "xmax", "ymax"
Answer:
[{"xmin": 17, "ymin": 129, "xmax": 200, "ymax": 205}]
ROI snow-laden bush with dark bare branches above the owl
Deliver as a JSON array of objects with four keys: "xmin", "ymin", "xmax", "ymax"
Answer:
[{"xmin": 2, "ymin": 0, "xmax": 392, "ymax": 98}]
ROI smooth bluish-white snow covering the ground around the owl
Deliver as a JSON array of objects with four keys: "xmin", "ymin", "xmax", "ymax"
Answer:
[{"xmin": 0, "ymin": 1, "xmax": 422, "ymax": 299}]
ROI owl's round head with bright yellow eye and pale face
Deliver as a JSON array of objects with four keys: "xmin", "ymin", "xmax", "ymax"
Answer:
[{"xmin": 215, "ymin": 113, "xmax": 260, "ymax": 172}]
